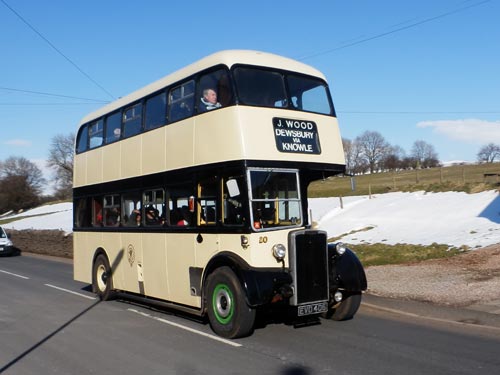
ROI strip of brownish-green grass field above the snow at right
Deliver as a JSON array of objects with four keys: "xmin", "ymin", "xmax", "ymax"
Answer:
[{"xmin": 309, "ymin": 163, "xmax": 500, "ymax": 198}]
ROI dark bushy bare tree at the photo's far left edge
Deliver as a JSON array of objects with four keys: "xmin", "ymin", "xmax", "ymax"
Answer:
[{"xmin": 0, "ymin": 157, "xmax": 45, "ymax": 211}]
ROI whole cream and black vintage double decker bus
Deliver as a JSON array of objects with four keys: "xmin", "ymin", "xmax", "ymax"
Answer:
[{"xmin": 73, "ymin": 50, "xmax": 367, "ymax": 338}]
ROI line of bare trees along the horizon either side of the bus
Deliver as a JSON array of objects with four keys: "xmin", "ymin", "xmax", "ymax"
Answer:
[{"xmin": 0, "ymin": 131, "xmax": 500, "ymax": 214}]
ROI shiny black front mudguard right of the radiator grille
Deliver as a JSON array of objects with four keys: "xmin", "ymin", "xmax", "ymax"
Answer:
[{"xmin": 328, "ymin": 243, "xmax": 368, "ymax": 292}]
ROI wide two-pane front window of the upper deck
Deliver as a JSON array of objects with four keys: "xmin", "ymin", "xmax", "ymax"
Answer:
[{"xmin": 234, "ymin": 67, "xmax": 334, "ymax": 115}]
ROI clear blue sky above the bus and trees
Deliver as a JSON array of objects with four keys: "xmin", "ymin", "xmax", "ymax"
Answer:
[{"xmin": 0, "ymin": 0, "xmax": 500, "ymax": 180}]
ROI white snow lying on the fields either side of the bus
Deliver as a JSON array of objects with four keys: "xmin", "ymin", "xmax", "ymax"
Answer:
[{"xmin": 0, "ymin": 191, "xmax": 500, "ymax": 248}]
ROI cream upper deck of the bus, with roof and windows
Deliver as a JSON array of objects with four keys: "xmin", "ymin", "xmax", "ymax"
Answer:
[{"xmin": 74, "ymin": 51, "xmax": 345, "ymax": 188}]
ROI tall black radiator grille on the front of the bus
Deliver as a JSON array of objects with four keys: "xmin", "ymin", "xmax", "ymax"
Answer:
[{"xmin": 288, "ymin": 230, "xmax": 329, "ymax": 306}]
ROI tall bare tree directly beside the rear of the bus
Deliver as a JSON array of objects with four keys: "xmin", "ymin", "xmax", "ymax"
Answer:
[{"xmin": 47, "ymin": 133, "xmax": 75, "ymax": 198}]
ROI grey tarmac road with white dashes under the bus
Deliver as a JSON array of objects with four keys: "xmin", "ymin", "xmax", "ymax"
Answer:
[{"xmin": 0, "ymin": 256, "xmax": 500, "ymax": 375}]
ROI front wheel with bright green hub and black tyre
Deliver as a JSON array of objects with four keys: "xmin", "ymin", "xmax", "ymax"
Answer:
[{"xmin": 206, "ymin": 267, "xmax": 256, "ymax": 339}]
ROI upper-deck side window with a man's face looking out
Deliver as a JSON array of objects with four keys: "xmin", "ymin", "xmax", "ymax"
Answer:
[{"xmin": 197, "ymin": 69, "xmax": 233, "ymax": 113}]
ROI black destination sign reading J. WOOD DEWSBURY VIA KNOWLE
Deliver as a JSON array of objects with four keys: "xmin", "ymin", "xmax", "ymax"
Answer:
[{"xmin": 273, "ymin": 117, "xmax": 321, "ymax": 154}]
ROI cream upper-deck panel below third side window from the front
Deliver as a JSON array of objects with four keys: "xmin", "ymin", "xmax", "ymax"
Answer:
[{"xmin": 142, "ymin": 127, "xmax": 167, "ymax": 178}]
